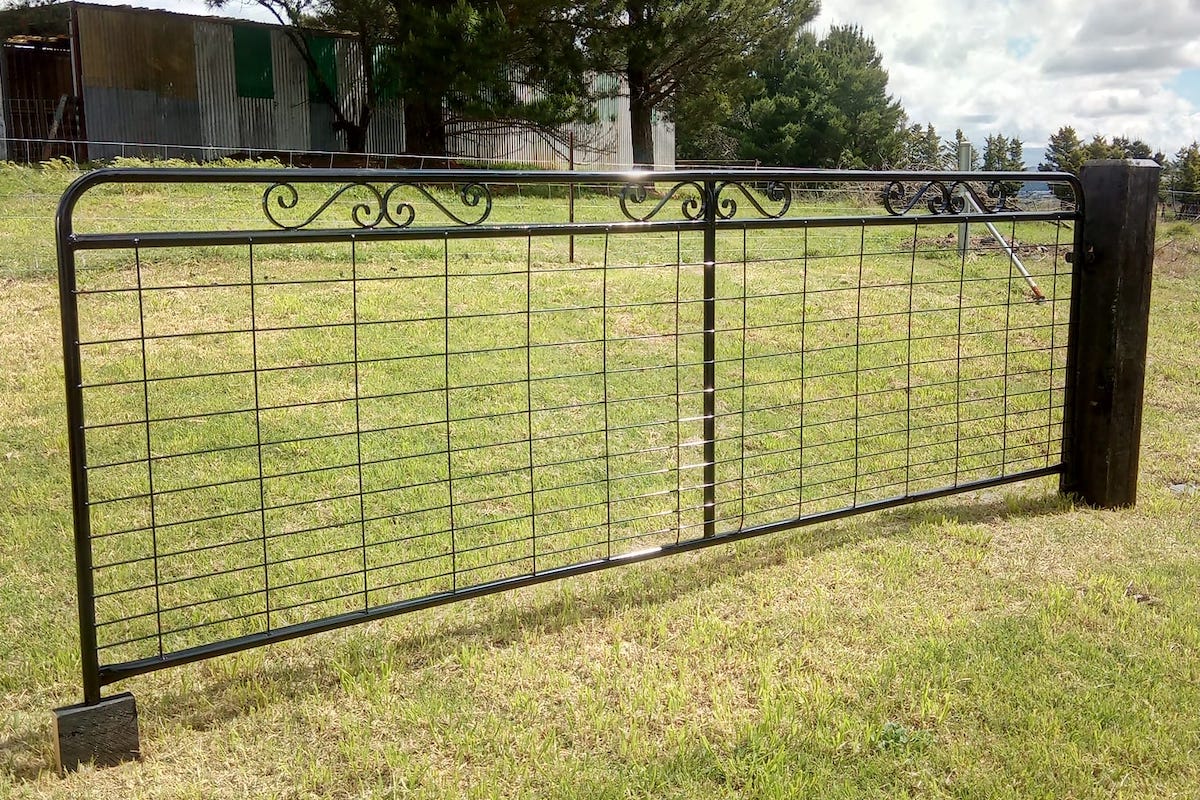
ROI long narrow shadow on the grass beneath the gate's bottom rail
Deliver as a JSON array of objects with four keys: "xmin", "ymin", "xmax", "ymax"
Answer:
[{"xmin": 152, "ymin": 484, "xmax": 1069, "ymax": 729}]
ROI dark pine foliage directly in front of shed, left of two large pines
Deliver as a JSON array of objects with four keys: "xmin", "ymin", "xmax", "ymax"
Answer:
[{"xmin": 216, "ymin": 0, "xmax": 593, "ymax": 155}]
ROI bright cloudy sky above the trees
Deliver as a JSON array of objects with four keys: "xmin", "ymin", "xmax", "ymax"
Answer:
[{"xmin": 79, "ymin": 0, "xmax": 1200, "ymax": 167}]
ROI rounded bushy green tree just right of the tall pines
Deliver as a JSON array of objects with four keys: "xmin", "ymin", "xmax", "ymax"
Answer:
[{"xmin": 733, "ymin": 26, "xmax": 904, "ymax": 168}]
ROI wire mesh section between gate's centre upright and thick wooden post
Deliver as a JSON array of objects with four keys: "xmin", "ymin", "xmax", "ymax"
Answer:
[{"xmin": 716, "ymin": 218, "xmax": 1070, "ymax": 529}]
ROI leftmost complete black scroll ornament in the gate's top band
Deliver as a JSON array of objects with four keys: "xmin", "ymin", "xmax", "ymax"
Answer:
[{"xmin": 263, "ymin": 181, "xmax": 492, "ymax": 230}]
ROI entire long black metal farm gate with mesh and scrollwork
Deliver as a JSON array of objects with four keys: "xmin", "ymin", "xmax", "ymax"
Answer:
[{"xmin": 59, "ymin": 170, "xmax": 1078, "ymax": 699}]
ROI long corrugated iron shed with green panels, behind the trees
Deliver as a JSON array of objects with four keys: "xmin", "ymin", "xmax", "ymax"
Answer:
[{"xmin": 0, "ymin": 2, "xmax": 674, "ymax": 168}]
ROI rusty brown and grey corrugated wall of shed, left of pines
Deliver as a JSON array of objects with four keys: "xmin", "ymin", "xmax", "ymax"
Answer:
[{"xmin": 71, "ymin": 5, "xmax": 403, "ymax": 158}]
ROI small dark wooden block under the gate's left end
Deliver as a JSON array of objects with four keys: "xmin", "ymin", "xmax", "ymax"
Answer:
[{"xmin": 54, "ymin": 692, "xmax": 142, "ymax": 775}]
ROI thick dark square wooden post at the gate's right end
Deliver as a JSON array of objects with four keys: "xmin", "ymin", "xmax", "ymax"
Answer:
[{"xmin": 1061, "ymin": 160, "xmax": 1159, "ymax": 509}]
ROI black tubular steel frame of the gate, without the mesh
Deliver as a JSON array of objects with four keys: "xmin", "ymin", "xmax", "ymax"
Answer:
[{"xmin": 55, "ymin": 169, "xmax": 1084, "ymax": 704}]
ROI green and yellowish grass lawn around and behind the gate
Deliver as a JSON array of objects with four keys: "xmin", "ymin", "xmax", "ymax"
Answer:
[{"xmin": 0, "ymin": 168, "xmax": 1200, "ymax": 798}]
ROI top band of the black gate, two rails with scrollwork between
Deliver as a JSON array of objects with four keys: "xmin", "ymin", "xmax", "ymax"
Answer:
[{"xmin": 56, "ymin": 167, "xmax": 1084, "ymax": 244}]
